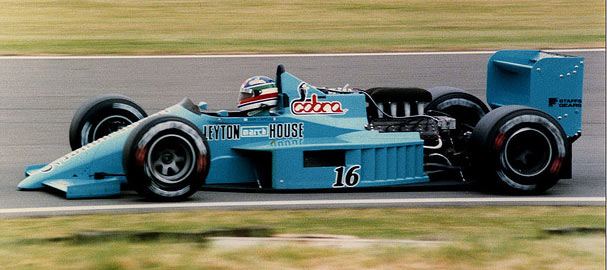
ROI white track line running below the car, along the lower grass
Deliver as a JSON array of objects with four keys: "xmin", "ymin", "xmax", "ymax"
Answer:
[{"xmin": 0, "ymin": 197, "xmax": 605, "ymax": 214}]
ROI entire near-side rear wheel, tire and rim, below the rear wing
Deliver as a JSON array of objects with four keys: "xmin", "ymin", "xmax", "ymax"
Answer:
[{"xmin": 469, "ymin": 105, "xmax": 571, "ymax": 195}]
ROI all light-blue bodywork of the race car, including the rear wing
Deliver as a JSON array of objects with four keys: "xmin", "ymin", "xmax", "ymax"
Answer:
[{"xmin": 18, "ymin": 50, "xmax": 583, "ymax": 198}]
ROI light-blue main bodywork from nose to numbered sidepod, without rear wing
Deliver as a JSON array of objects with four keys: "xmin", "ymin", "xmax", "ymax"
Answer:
[{"xmin": 18, "ymin": 72, "xmax": 428, "ymax": 198}]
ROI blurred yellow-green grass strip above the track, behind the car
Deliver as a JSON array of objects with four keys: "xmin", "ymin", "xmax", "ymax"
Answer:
[{"xmin": 0, "ymin": 0, "xmax": 605, "ymax": 55}]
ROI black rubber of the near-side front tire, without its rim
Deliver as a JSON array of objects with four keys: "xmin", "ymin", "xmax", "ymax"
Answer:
[{"xmin": 123, "ymin": 115, "xmax": 210, "ymax": 201}]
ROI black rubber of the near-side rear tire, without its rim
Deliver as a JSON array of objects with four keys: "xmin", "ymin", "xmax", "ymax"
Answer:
[{"xmin": 470, "ymin": 106, "xmax": 570, "ymax": 195}]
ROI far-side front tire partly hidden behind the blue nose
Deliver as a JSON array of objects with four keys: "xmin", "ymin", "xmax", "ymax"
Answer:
[{"xmin": 70, "ymin": 94, "xmax": 147, "ymax": 150}]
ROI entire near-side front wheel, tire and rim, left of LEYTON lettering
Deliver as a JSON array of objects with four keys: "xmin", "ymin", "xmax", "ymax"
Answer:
[{"xmin": 122, "ymin": 115, "xmax": 210, "ymax": 201}]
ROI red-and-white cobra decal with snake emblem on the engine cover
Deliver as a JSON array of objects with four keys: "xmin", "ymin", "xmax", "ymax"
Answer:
[{"xmin": 291, "ymin": 82, "xmax": 347, "ymax": 115}]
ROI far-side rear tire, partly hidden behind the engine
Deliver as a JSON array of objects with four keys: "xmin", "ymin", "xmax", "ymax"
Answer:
[{"xmin": 425, "ymin": 86, "xmax": 489, "ymax": 129}]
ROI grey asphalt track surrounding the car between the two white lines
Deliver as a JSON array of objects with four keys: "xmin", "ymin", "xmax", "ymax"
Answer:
[{"xmin": 0, "ymin": 49, "xmax": 605, "ymax": 217}]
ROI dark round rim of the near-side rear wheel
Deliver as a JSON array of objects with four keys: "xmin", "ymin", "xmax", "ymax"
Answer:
[{"xmin": 502, "ymin": 127, "xmax": 552, "ymax": 177}]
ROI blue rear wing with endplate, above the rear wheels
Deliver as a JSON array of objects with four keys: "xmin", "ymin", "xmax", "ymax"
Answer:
[{"xmin": 487, "ymin": 50, "xmax": 584, "ymax": 138}]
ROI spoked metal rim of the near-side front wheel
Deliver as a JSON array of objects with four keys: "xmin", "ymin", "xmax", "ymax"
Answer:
[{"xmin": 147, "ymin": 134, "xmax": 195, "ymax": 184}]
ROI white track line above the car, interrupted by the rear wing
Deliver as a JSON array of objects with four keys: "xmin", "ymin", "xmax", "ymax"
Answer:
[{"xmin": 0, "ymin": 48, "xmax": 605, "ymax": 60}]
